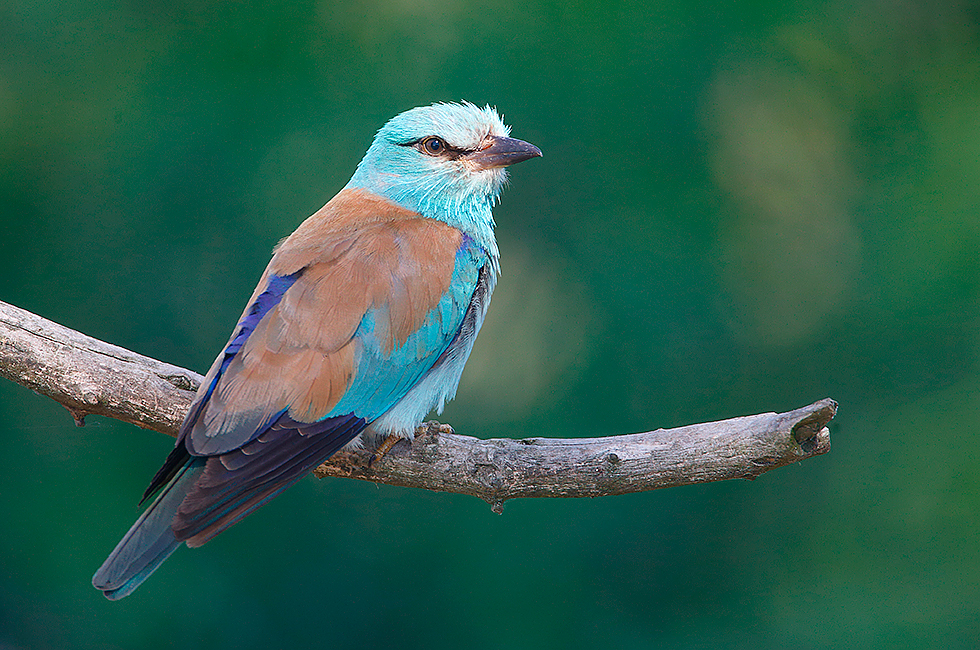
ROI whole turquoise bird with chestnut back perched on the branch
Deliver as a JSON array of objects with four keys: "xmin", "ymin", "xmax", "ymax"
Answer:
[{"xmin": 92, "ymin": 102, "xmax": 541, "ymax": 600}]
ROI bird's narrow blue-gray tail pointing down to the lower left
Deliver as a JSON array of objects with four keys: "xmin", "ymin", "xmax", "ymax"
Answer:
[{"xmin": 92, "ymin": 458, "xmax": 204, "ymax": 600}]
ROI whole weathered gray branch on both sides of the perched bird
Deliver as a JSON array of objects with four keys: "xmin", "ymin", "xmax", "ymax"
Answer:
[{"xmin": 0, "ymin": 302, "xmax": 837, "ymax": 512}]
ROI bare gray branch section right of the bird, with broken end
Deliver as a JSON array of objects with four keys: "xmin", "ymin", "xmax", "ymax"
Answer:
[{"xmin": 313, "ymin": 399, "xmax": 837, "ymax": 512}]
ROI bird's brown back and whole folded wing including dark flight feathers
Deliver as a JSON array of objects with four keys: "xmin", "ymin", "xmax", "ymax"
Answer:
[{"xmin": 142, "ymin": 190, "xmax": 487, "ymax": 545}]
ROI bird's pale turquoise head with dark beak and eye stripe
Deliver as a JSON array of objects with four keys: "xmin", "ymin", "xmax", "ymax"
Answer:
[{"xmin": 347, "ymin": 102, "xmax": 541, "ymax": 239}]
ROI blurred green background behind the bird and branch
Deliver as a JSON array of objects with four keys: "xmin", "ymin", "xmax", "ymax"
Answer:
[{"xmin": 0, "ymin": 0, "xmax": 980, "ymax": 650}]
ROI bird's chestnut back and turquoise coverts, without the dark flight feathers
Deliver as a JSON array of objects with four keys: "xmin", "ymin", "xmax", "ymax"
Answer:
[{"xmin": 185, "ymin": 190, "xmax": 479, "ymax": 455}]
